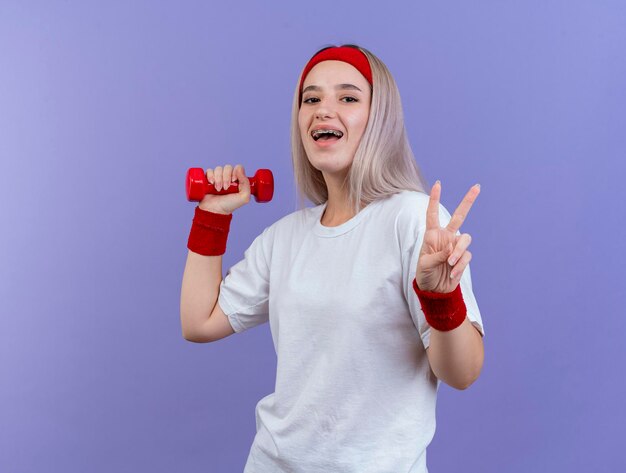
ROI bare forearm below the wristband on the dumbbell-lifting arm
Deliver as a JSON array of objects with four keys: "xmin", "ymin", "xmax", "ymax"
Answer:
[{"xmin": 180, "ymin": 250, "xmax": 222, "ymax": 339}]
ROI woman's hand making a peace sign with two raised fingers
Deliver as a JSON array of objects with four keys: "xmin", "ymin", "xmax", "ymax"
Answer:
[{"xmin": 415, "ymin": 181, "xmax": 480, "ymax": 292}]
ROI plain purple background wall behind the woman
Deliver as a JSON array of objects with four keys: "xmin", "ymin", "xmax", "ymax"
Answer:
[{"xmin": 0, "ymin": 0, "xmax": 626, "ymax": 473}]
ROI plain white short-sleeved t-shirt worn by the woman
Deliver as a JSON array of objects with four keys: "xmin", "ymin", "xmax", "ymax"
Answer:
[{"xmin": 218, "ymin": 191, "xmax": 484, "ymax": 473}]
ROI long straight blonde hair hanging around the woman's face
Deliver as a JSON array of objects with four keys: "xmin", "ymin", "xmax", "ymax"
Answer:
[{"xmin": 291, "ymin": 44, "xmax": 428, "ymax": 215}]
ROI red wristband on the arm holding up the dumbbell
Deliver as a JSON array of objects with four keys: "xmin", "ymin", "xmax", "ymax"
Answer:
[{"xmin": 187, "ymin": 206, "xmax": 233, "ymax": 256}]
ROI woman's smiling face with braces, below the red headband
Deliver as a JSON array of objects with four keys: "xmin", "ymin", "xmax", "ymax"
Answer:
[{"xmin": 298, "ymin": 61, "xmax": 371, "ymax": 177}]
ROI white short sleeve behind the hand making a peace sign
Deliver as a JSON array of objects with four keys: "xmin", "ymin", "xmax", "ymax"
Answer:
[{"xmin": 399, "ymin": 199, "xmax": 485, "ymax": 349}]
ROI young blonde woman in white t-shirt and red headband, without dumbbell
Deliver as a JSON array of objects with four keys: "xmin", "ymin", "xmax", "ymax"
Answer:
[{"xmin": 181, "ymin": 45, "xmax": 484, "ymax": 473}]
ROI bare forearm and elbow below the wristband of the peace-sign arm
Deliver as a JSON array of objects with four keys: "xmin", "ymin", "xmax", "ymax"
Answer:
[{"xmin": 427, "ymin": 317, "xmax": 485, "ymax": 389}]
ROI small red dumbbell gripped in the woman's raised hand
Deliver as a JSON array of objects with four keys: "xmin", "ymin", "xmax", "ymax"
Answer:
[{"xmin": 185, "ymin": 168, "xmax": 274, "ymax": 203}]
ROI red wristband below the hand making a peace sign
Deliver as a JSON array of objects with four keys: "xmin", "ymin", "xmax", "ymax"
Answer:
[{"xmin": 413, "ymin": 279, "xmax": 467, "ymax": 332}]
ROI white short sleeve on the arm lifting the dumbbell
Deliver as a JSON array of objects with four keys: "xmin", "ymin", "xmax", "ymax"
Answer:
[{"xmin": 218, "ymin": 227, "xmax": 273, "ymax": 333}]
